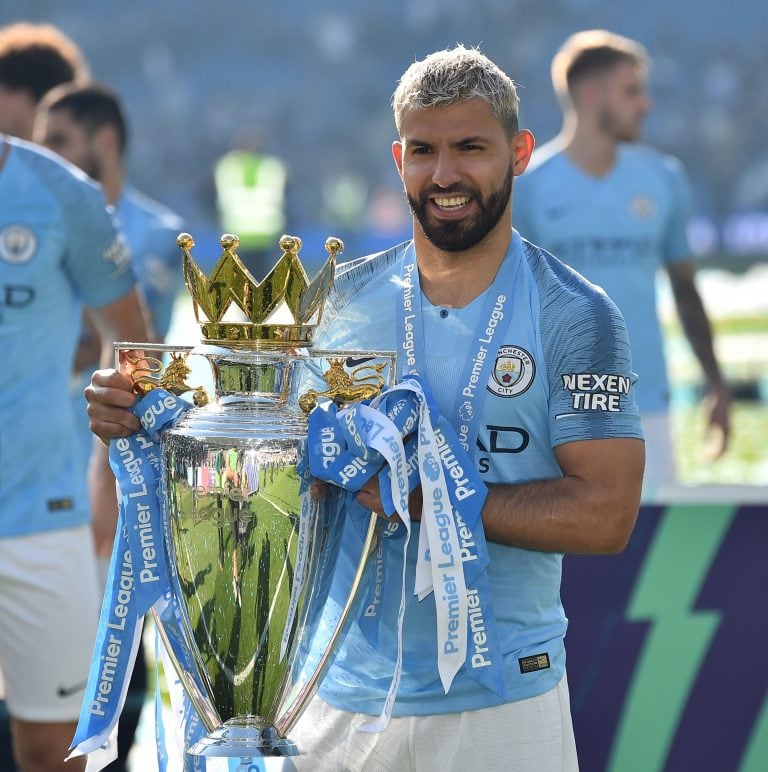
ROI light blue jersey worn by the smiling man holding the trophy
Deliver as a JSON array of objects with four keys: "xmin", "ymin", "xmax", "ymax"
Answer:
[{"xmin": 317, "ymin": 232, "xmax": 642, "ymax": 715}]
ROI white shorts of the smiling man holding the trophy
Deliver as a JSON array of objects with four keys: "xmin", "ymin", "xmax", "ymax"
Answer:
[{"xmin": 288, "ymin": 676, "xmax": 579, "ymax": 772}]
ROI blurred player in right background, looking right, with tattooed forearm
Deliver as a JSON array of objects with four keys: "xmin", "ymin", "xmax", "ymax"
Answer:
[{"xmin": 515, "ymin": 30, "xmax": 729, "ymax": 487}]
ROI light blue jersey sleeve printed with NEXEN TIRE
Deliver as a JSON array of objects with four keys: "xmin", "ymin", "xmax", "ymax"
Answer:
[{"xmin": 540, "ymin": 252, "xmax": 643, "ymax": 447}]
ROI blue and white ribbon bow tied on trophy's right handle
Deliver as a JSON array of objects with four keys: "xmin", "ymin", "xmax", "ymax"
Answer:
[{"xmin": 309, "ymin": 376, "xmax": 506, "ymax": 731}]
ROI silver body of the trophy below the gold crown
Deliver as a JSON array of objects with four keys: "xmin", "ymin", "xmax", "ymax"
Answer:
[{"xmin": 156, "ymin": 347, "xmax": 378, "ymax": 756}]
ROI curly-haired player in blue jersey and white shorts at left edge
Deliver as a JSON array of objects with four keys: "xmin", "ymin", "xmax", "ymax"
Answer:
[{"xmin": 0, "ymin": 23, "xmax": 150, "ymax": 772}]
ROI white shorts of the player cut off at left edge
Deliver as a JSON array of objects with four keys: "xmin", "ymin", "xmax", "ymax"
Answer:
[{"xmin": 0, "ymin": 525, "xmax": 103, "ymax": 723}]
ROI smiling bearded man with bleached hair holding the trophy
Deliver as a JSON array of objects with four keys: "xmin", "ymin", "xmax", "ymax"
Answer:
[{"xmin": 88, "ymin": 46, "xmax": 644, "ymax": 772}]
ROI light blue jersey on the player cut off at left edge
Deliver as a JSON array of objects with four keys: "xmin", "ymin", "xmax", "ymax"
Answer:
[{"xmin": 0, "ymin": 137, "xmax": 134, "ymax": 536}]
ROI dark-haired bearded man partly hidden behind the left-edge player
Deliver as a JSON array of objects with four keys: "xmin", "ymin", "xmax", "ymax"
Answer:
[{"xmin": 33, "ymin": 78, "xmax": 183, "ymax": 772}]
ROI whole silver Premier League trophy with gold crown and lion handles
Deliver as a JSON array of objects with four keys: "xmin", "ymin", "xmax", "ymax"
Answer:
[{"xmin": 122, "ymin": 234, "xmax": 393, "ymax": 756}]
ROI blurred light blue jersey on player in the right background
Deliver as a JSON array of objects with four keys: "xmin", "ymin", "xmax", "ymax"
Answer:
[{"xmin": 514, "ymin": 144, "xmax": 691, "ymax": 413}]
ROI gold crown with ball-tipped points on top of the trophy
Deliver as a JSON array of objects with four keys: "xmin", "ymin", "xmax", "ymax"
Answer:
[{"xmin": 176, "ymin": 233, "xmax": 344, "ymax": 348}]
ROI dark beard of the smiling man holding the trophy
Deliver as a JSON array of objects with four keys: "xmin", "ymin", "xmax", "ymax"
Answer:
[{"xmin": 408, "ymin": 164, "xmax": 513, "ymax": 252}]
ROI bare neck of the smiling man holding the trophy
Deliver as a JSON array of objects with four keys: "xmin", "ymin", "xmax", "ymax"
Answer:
[{"xmin": 414, "ymin": 218, "xmax": 512, "ymax": 308}]
